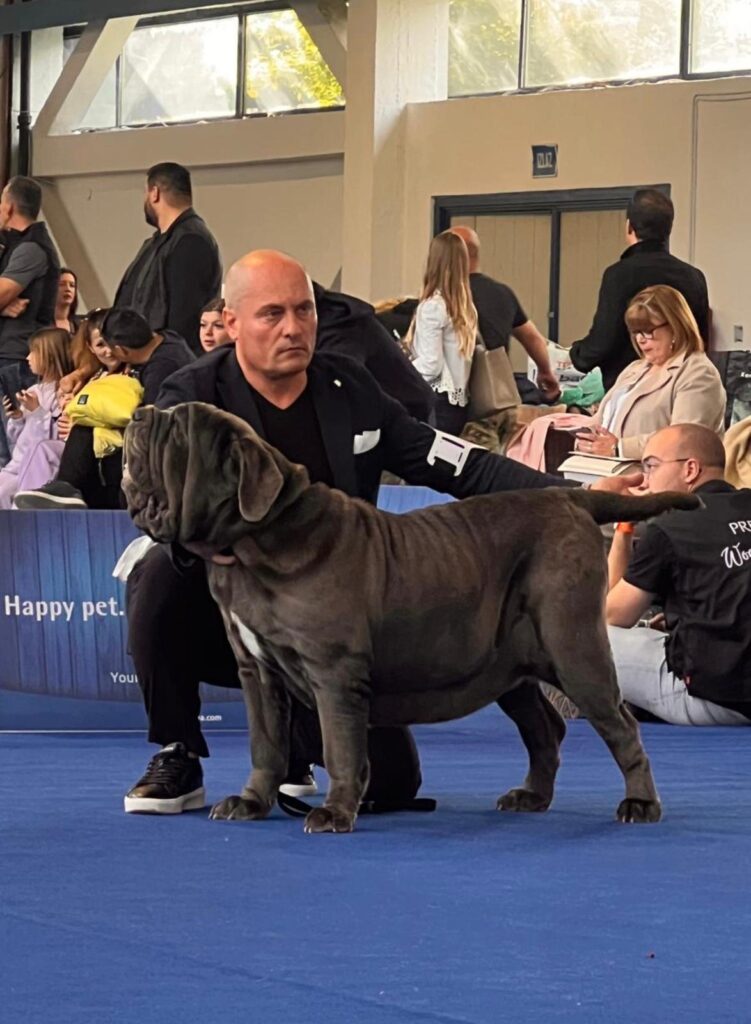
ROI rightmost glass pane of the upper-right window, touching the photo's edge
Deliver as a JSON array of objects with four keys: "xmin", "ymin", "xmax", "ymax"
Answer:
[{"xmin": 691, "ymin": 0, "xmax": 751, "ymax": 72}]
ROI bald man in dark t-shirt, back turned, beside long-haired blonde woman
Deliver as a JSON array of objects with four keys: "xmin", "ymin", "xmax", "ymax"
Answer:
[{"xmin": 451, "ymin": 225, "xmax": 560, "ymax": 401}]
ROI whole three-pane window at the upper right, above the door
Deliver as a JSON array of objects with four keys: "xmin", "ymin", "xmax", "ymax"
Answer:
[{"xmin": 449, "ymin": 0, "xmax": 751, "ymax": 96}]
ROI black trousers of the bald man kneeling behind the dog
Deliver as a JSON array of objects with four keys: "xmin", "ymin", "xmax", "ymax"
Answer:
[{"xmin": 127, "ymin": 547, "xmax": 422, "ymax": 802}]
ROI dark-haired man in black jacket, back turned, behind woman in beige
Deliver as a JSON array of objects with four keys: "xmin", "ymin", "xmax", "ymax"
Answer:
[{"xmin": 571, "ymin": 188, "xmax": 709, "ymax": 390}]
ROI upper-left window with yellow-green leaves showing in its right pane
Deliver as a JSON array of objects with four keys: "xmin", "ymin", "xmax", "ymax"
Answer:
[{"xmin": 54, "ymin": 7, "xmax": 344, "ymax": 131}]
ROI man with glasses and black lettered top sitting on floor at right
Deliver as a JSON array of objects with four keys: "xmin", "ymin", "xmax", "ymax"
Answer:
[{"xmin": 607, "ymin": 424, "xmax": 751, "ymax": 725}]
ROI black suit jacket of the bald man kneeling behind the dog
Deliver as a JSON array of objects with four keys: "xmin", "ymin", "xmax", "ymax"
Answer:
[{"xmin": 156, "ymin": 345, "xmax": 571, "ymax": 503}]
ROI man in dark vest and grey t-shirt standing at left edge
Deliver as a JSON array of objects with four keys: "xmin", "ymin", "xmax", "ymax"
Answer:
[{"xmin": 0, "ymin": 175, "xmax": 60, "ymax": 466}]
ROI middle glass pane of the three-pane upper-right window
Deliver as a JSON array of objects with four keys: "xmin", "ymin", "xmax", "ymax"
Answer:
[{"xmin": 525, "ymin": 0, "xmax": 684, "ymax": 86}]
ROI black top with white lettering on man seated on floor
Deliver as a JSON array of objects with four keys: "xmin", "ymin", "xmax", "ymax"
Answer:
[{"xmin": 624, "ymin": 480, "xmax": 751, "ymax": 717}]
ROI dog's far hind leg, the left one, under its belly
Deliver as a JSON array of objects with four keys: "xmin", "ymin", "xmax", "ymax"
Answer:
[{"xmin": 496, "ymin": 680, "xmax": 566, "ymax": 811}]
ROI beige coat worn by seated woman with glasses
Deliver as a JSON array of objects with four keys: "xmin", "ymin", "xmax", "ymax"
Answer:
[{"xmin": 593, "ymin": 352, "xmax": 726, "ymax": 459}]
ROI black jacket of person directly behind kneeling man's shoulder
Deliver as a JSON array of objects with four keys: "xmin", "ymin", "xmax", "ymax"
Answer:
[{"xmin": 312, "ymin": 282, "xmax": 434, "ymax": 421}]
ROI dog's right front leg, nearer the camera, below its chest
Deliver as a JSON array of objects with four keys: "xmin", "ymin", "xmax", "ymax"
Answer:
[{"xmin": 305, "ymin": 680, "xmax": 370, "ymax": 833}]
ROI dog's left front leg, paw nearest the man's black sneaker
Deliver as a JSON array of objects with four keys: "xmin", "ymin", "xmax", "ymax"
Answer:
[{"xmin": 210, "ymin": 656, "xmax": 290, "ymax": 821}]
